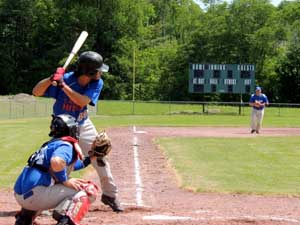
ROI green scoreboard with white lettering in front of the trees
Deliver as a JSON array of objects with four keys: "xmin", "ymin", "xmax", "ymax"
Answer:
[{"xmin": 189, "ymin": 63, "xmax": 255, "ymax": 94}]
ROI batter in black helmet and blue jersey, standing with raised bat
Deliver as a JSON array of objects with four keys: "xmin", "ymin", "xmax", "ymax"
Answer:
[{"xmin": 32, "ymin": 51, "xmax": 123, "ymax": 212}]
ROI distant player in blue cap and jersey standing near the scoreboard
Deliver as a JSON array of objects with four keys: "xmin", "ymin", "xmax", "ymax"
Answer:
[{"xmin": 249, "ymin": 87, "xmax": 269, "ymax": 134}]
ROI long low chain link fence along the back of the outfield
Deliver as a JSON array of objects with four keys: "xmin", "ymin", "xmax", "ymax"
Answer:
[{"xmin": 0, "ymin": 95, "xmax": 300, "ymax": 120}]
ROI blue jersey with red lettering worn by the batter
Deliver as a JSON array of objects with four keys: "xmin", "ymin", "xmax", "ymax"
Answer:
[{"xmin": 45, "ymin": 72, "xmax": 103, "ymax": 124}]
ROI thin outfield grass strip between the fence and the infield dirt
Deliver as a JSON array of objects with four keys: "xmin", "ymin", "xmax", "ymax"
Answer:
[{"xmin": 93, "ymin": 115, "xmax": 300, "ymax": 127}]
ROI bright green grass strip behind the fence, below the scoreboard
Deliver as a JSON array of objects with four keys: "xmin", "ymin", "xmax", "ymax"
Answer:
[{"xmin": 97, "ymin": 100, "xmax": 300, "ymax": 118}]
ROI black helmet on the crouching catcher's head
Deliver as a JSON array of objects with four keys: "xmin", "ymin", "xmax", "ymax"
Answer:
[{"xmin": 49, "ymin": 114, "xmax": 79, "ymax": 140}]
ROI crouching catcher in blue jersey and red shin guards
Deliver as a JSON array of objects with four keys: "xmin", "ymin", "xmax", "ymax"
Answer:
[{"xmin": 14, "ymin": 114, "xmax": 99, "ymax": 225}]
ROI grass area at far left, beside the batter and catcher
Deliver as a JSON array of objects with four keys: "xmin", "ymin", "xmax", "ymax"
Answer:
[{"xmin": 0, "ymin": 119, "xmax": 49, "ymax": 186}]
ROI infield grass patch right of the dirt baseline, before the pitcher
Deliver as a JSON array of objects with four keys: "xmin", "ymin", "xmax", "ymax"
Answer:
[{"xmin": 157, "ymin": 137, "xmax": 300, "ymax": 196}]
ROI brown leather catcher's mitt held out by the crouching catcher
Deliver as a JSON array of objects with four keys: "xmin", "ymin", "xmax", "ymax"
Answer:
[{"xmin": 89, "ymin": 131, "xmax": 112, "ymax": 166}]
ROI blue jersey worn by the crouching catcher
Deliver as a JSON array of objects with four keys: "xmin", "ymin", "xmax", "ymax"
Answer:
[{"xmin": 14, "ymin": 139, "xmax": 84, "ymax": 194}]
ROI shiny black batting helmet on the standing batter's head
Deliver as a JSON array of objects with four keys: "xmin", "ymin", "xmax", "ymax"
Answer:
[{"xmin": 78, "ymin": 51, "xmax": 109, "ymax": 76}]
